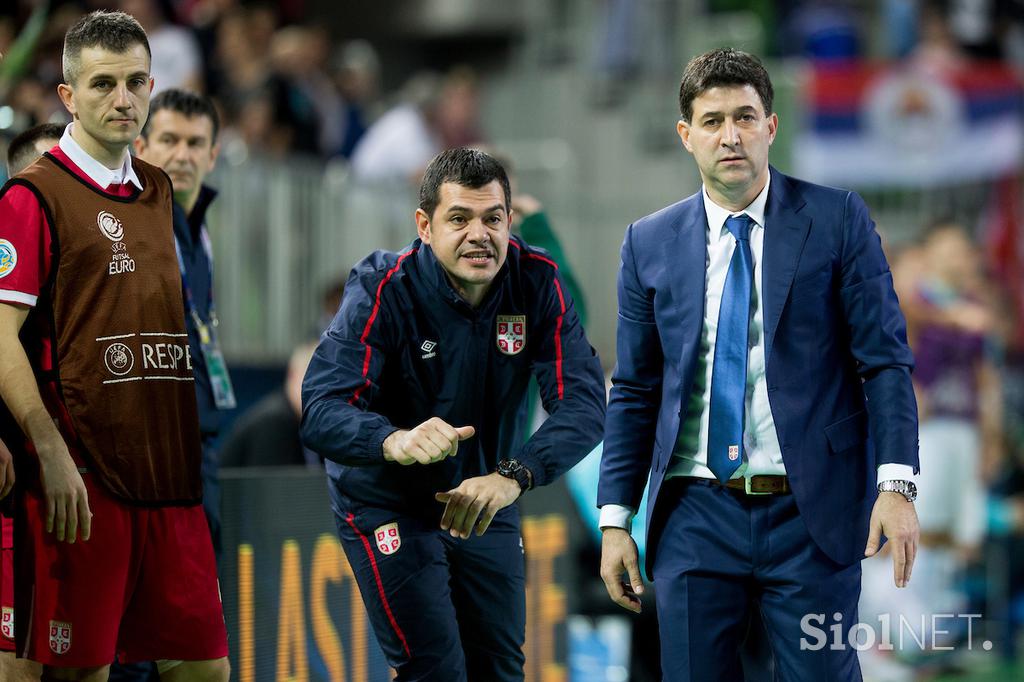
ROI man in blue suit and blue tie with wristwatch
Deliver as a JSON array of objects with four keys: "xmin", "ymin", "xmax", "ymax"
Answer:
[{"xmin": 598, "ymin": 49, "xmax": 918, "ymax": 682}]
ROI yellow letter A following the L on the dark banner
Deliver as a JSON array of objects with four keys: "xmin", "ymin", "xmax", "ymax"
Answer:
[{"xmin": 278, "ymin": 540, "xmax": 309, "ymax": 682}]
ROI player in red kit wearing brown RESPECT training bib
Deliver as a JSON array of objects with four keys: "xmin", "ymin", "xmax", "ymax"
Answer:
[{"xmin": 0, "ymin": 11, "xmax": 228, "ymax": 682}]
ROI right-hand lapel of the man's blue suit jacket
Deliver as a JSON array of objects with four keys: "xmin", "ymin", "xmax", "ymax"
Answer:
[{"xmin": 761, "ymin": 168, "xmax": 811, "ymax": 361}]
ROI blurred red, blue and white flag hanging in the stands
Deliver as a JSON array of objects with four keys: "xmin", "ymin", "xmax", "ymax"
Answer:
[{"xmin": 793, "ymin": 62, "xmax": 1024, "ymax": 187}]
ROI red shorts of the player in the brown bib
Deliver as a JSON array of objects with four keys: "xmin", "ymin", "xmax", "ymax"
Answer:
[{"xmin": 16, "ymin": 466, "xmax": 227, "ymax": 668}]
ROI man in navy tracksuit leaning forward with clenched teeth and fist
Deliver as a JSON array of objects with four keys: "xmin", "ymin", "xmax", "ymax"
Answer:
[{"xmin": 302, "ymin": 148, "xmax": 604, "ymax": 682}]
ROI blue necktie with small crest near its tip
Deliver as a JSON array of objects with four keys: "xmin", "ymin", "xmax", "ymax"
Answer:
[{"xmin": 708, "ymin": 214, "xmax": 754, "ymax": 483}]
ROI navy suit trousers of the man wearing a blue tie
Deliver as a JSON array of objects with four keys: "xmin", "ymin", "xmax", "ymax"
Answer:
[{"xmin": 652, "ymin": 478, "xmax": 861, "ymax": 682}]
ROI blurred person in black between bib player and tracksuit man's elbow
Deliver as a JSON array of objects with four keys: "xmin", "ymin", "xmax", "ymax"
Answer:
[{"xmin": 220, "ymin": 343, "xmax": 319, "ymax": 467}]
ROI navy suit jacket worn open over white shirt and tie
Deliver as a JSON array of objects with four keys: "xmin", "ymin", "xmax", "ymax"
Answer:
[{"xmin": 597, "ymin": 169, "xmax": 918, "ymax": 574}]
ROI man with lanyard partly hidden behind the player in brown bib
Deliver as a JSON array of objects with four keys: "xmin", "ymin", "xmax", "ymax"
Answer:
[{"xmin": 135, "ymin": 89, "xmax": 234, "ymax": 558}]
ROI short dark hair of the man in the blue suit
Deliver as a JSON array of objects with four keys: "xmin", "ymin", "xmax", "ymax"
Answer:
[{"xmin": 679, "ymin": 47, "xmax": 775, "ymax": 123}]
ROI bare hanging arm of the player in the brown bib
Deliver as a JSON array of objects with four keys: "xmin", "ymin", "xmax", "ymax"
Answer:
[{"xmin": 0, "ymin": 303, "xmax": 92, "ymax": 543}]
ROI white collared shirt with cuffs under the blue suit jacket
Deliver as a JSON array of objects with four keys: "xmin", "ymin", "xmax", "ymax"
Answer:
[{"xmin": 599, "ymin": 176, "xmax": 913, "ymax": 528}]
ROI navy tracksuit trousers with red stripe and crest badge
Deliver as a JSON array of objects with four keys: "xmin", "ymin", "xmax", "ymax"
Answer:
[{"xmin": 333, "ymin": 500, "xmax": 526, "ymax": 682}]
